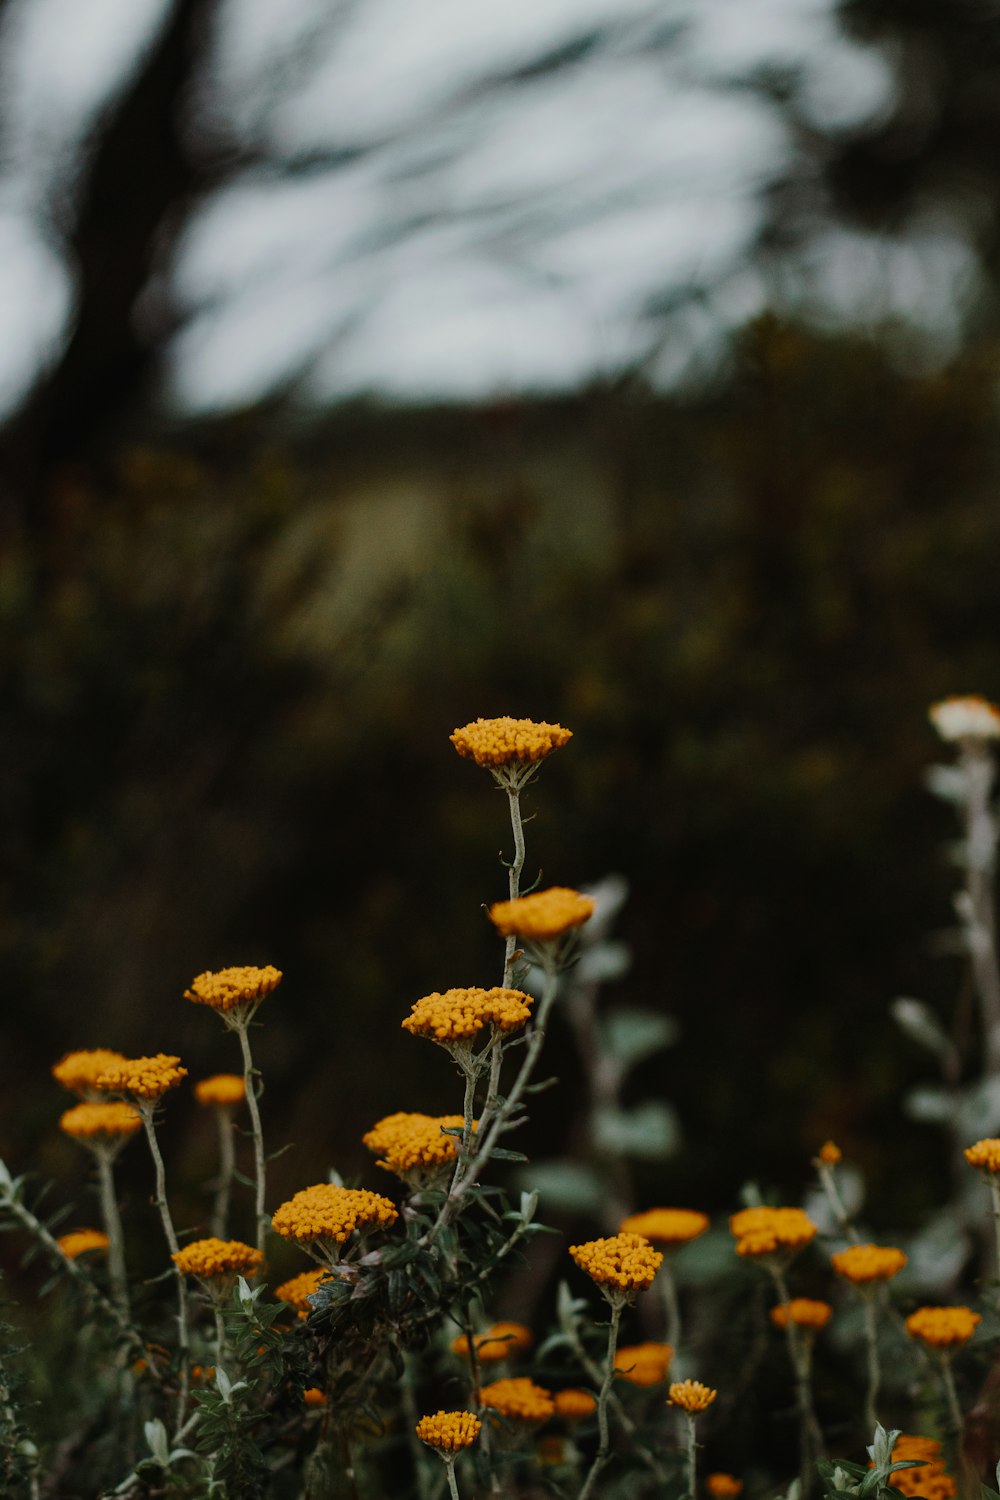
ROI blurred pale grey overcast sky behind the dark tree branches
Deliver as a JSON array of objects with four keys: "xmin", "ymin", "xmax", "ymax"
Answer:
[{"xmin": 0, "ymin": 0, "xmax": 967, "ymax": 411}]
